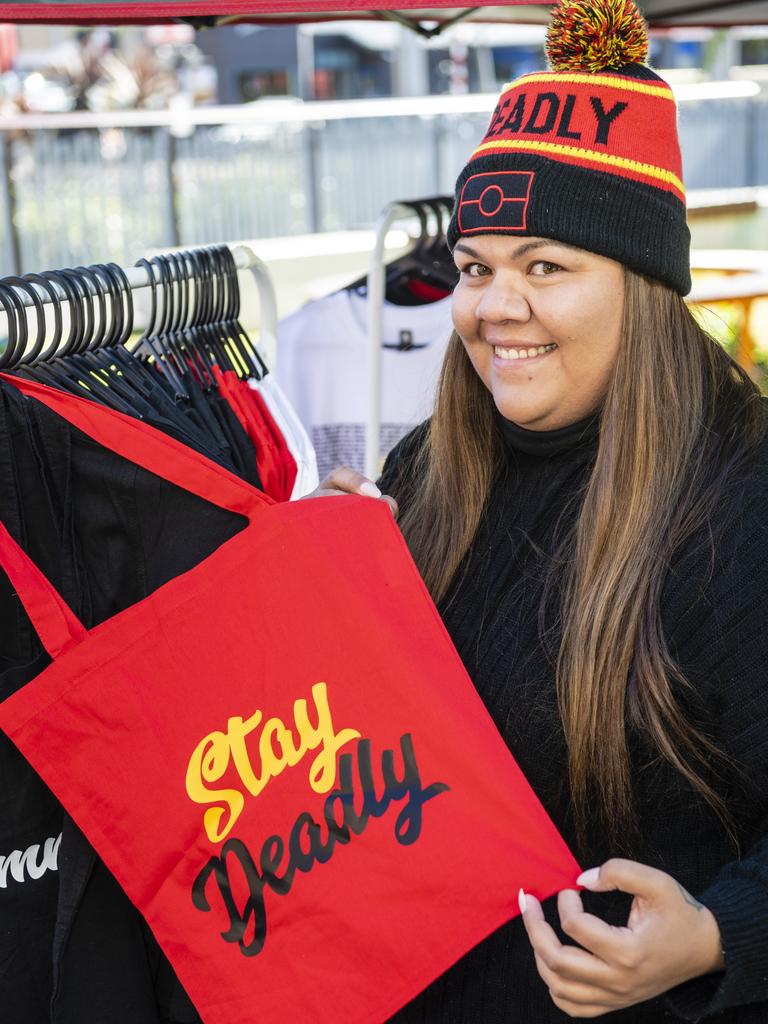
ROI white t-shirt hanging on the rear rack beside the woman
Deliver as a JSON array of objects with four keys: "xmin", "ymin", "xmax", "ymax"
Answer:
[{"xmin": 276, "ymin": 291, "xmax": 452, "ymax": 479}]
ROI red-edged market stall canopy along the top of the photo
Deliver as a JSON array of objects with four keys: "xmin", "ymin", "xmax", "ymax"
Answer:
[{"xmin": 0, "ymin": 0, "xmax": 768, "ymax": 35}]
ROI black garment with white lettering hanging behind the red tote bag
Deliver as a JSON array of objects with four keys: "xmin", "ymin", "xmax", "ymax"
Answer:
[{"xmin": 0, "ymin": 382, "xmax": 244, "ymax": 1024}]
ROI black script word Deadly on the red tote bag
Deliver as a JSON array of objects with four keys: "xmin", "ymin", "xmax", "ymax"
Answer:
[{"xmin": 191, "ymin": 733, "xmax": 450, "ymax": 956}]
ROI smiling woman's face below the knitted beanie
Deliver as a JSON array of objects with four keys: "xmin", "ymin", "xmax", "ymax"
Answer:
[{"xmin": 453, "ymin": 234, "xmax": 624, "ymax": 430}]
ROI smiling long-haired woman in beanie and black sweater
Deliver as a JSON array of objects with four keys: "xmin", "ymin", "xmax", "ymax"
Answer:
[{"xmin": 309, "ymin": 0, "xmax": 768, "ymax": 1024}]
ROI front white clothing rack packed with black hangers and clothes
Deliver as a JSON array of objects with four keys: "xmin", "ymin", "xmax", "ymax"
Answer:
[{"xmin": 0, "ymin": 245, "xmax": 317, "ymax": 501}]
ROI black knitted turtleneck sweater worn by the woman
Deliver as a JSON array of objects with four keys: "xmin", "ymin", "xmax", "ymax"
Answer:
[{"xmin": 379, "ymin": 418, "xmax": 768, "ymax": 1024}]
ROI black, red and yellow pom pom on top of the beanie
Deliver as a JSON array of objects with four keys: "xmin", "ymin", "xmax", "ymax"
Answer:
[{"xmin": 547, "ymin": 0, "xmax": 648, "ymax": 72}]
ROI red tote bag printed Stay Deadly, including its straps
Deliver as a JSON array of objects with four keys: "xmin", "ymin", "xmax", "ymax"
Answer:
[{"xmin": 0, "ymin": 378, "xmax": 579, "ymax": 1024}]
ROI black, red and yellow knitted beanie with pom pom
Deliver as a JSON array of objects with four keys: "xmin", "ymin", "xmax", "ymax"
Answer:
[{"xmin": 447, "ymin": 0, "xmax": 690, "ymax": 295}]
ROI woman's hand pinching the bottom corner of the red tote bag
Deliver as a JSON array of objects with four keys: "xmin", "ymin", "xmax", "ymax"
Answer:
[{"xmin": 520, "ymin": 860, "xmax": 725, "ymax": 1017}]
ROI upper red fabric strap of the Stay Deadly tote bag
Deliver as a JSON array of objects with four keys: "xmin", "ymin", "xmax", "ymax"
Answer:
[{"xmin": 0, "ymin": 374, "xmax": 274, "ymax": 519}]
